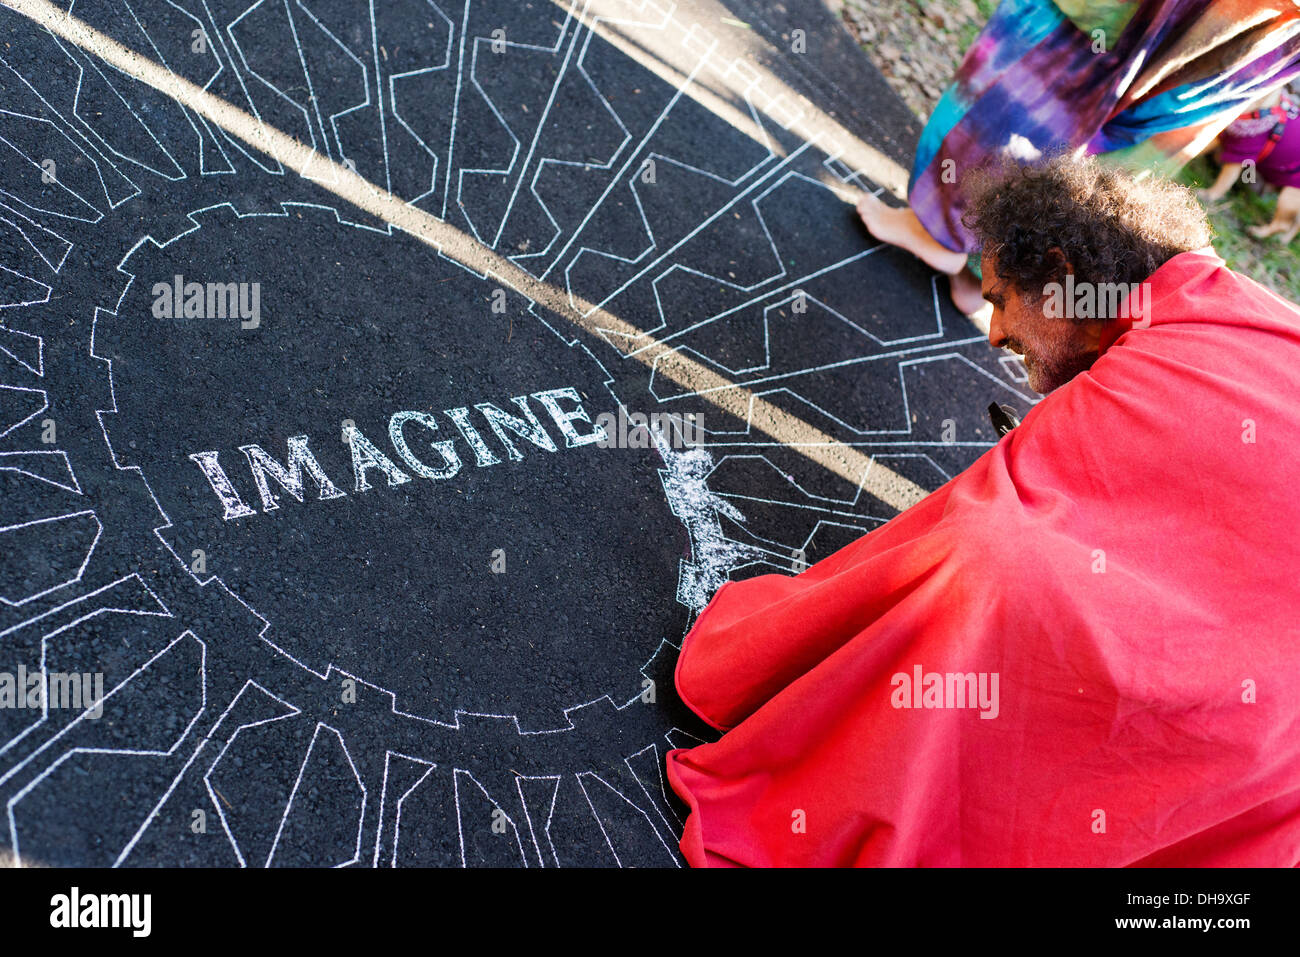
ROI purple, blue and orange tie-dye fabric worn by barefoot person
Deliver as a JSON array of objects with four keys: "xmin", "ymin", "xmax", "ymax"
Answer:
[{"xmin": 907, "ymin": 0, "xmax": 1300, "ymax": 252}]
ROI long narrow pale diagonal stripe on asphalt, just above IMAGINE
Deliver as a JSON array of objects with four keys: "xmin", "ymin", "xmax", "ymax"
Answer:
[{"xmin": 3, "ymin": 0, "xmax": 928, "ymax": 511}]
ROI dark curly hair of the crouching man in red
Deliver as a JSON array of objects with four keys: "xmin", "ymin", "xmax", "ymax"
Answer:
[{"xmin": 962, "ymin": 153, "xmax": 1210, "ymax": 319}]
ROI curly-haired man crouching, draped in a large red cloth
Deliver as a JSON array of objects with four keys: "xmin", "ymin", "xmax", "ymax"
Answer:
[{"xmin": 668, "ymin": 157, "xmax": 1300, "ymax": 866}]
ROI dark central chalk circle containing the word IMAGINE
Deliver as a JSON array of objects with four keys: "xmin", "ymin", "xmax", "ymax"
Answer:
[{"xmin": 96, "ymin": 204, "xmax": 690, "ymax": 729}]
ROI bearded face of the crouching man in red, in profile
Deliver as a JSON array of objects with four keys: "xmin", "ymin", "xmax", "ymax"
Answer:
[{"xmin": 980, "ymin": 254, "xmax": 1104, "ymax": 395}]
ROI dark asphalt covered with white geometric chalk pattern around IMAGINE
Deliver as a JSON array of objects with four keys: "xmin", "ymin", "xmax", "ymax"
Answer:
[{"xmin": 0, "ymin": 0, "xmax": 1034, "ymax": 867}]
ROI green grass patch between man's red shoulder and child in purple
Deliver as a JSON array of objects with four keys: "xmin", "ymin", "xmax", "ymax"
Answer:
[{"xmin": 1178, "ymin": 156, "xmax": 1300, "ymax": 302}]
